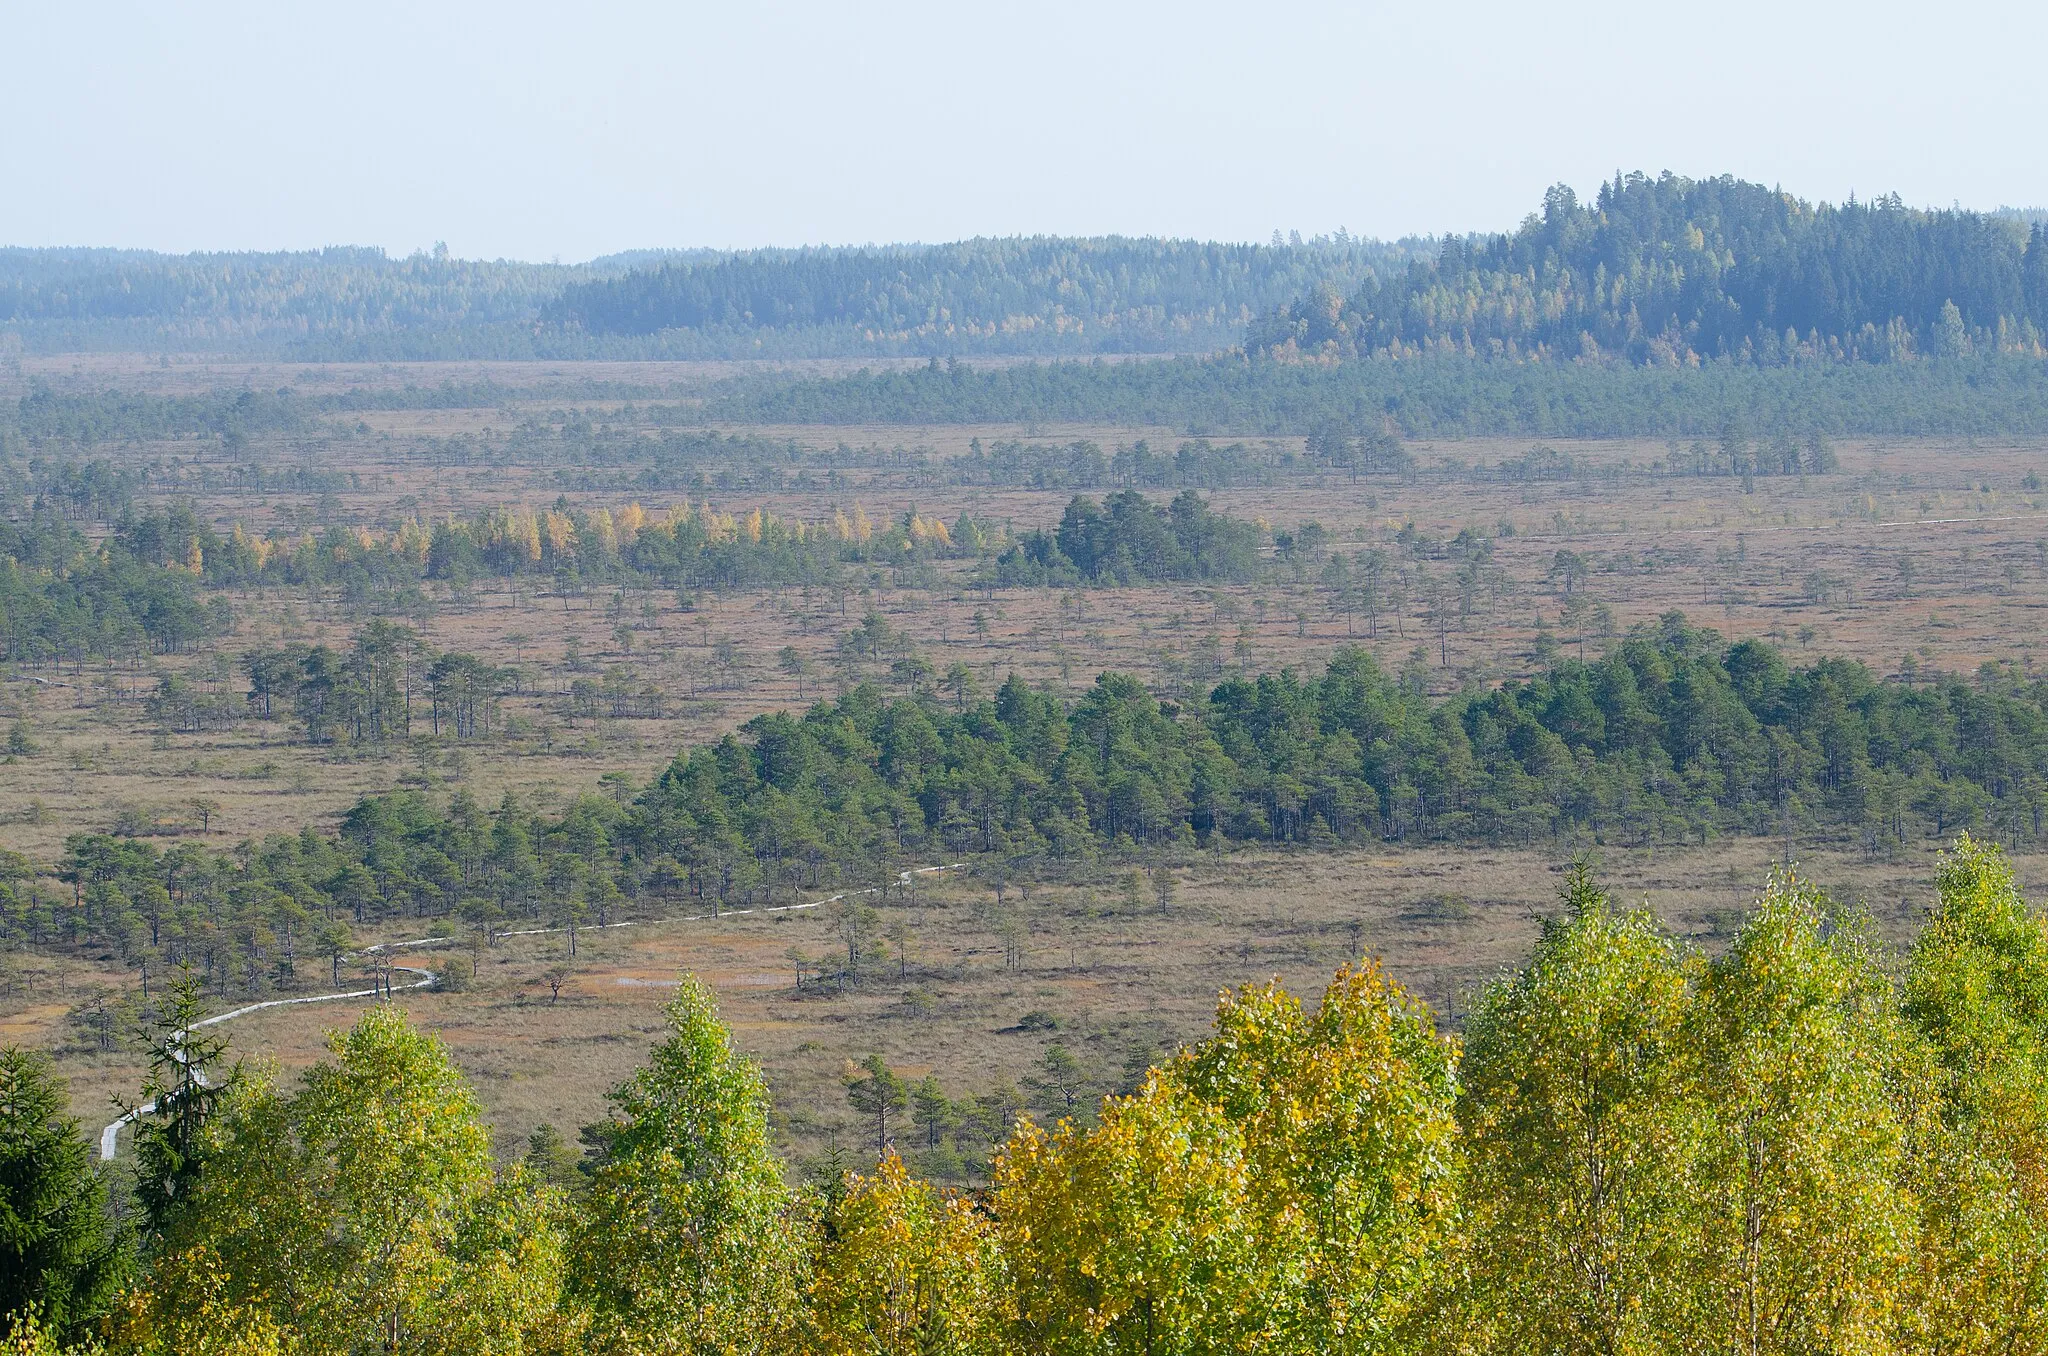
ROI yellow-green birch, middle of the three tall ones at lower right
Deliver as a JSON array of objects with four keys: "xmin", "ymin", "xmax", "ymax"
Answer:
[{"xmin": 1679, "ymin": 875, "xmax": 1915, "ymax": 1356}]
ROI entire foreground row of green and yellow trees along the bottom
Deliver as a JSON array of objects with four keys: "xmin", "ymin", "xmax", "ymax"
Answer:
[{"xmin": 19, "ymin": 838, "xmax": 2048, "ymax": 1356}]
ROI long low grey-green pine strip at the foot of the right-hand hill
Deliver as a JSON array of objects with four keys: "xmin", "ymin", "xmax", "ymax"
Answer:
[{"xmin": 705, "ymin": 354, "xmax": 2048, "ymax": 438}]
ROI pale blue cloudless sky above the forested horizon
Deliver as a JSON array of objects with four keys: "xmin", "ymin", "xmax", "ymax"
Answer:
[{"xmin": 0, "ymin": 0, "xmax": 2048, "ymax": 262}]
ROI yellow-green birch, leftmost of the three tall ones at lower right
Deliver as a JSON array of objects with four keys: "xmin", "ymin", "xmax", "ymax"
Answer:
[{"xmin": 1458, "ymin": 868, "xmax": 1702, "ymax": 1356}]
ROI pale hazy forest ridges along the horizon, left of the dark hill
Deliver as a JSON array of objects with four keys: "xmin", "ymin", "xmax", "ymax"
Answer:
[{"xmin": 0, "ymin": 234, "xmax": 1434, "ymax": 363}]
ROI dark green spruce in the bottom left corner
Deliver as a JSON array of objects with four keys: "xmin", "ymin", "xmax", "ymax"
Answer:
[{"xmin": 0, "ymin": 1045, "xmax": 127, "ymax": 1336}]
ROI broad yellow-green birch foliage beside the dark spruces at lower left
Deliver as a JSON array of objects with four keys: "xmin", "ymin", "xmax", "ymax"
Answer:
[{"xmin": 142, "ymin": 1008, "xmax": 575, "ymax": 1354}]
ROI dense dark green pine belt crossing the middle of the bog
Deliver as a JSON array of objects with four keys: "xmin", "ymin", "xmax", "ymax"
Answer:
[{"xmin": 19, "ymin": 615, "xmax": 2048, "ymax": 991}]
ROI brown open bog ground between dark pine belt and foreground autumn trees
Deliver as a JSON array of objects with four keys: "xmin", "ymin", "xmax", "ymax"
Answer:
[{"xmin": 24, "ymin": 840, "xmax": 2048, "ymax": 1157}]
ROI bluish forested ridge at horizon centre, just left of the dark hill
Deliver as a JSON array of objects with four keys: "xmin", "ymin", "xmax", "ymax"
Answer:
[{"xmin": 545, "ymin": 236, "xmax": 1413, "ymax": 354}]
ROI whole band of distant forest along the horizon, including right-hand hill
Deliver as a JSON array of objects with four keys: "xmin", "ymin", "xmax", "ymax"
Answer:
[{"xmin": 12, "ymin": 172, "xmax": 2048, "ymax": 378}]
